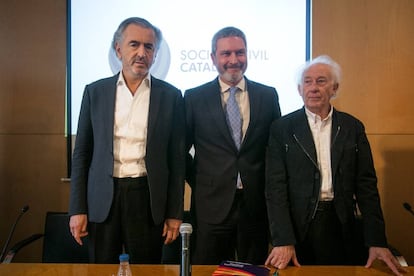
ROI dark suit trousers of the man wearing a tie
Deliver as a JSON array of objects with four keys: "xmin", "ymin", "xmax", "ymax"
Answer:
[{"xmin": 192, "ymin": 191, "xmax": 268, "ymax": 265}]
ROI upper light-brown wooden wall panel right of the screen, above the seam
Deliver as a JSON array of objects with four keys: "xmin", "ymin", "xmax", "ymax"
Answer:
[{"xmin": 312, "ymin": 0, "xmax": 414, "ymax": 134}]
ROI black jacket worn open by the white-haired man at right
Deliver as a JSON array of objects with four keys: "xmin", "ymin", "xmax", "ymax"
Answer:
[{"xmin": 266, "ymin": 108, "xmax": 387, "ymax": 247}]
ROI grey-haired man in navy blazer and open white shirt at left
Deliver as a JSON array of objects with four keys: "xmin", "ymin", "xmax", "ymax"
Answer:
[{"xmin": 69, "ymin": 17, "xmax": 185, "ymax": 263}]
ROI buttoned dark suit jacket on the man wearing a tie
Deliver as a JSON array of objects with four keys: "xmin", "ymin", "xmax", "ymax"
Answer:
[{"xmin": 184, "ymin": 78, "xmax": 280, "ymax": 224}]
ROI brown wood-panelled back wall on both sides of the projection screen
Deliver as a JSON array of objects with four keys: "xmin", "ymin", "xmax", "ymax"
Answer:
[{"xmin": 0, "ymin": 0, "xmax": 414, "ymax": 265}]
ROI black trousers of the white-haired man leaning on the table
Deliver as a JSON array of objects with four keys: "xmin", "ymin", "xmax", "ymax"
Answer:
[{"xmin": 296, "ymin": 201, "xmax": 355, "ymax": 265}]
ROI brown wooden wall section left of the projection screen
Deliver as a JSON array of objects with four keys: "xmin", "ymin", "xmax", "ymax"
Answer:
[{"xmin": 0, "ymin": 0, "xmax": 68, "ymax": 262}]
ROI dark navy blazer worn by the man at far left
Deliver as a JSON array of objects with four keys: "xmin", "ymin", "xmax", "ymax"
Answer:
[{"xmin": 69, "ymin": 74, "xmax": 185, "ymax": 224}]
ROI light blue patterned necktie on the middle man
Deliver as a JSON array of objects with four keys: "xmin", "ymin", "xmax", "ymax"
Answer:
[{"xmin": 226, "ymin": 86, "xmax": 242, "ymax": 149}]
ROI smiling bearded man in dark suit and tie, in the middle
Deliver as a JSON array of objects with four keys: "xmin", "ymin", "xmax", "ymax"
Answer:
[{"xmin": 184, "ymin": 27, "xmax": 280, "ymax": 264}]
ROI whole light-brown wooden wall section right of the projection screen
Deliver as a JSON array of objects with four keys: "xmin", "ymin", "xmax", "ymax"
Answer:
[{"xmin": 312, "ymin": 0, "xmax": 414, "ymax": 265}]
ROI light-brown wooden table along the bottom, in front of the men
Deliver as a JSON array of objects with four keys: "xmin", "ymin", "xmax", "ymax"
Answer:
[{"xmin": 0, "ymin": 263, "xmax": 414, "ymax": 276}]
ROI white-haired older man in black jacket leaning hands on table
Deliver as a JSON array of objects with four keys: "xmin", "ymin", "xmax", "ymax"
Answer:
[{"xmin": 266, "ymin": 56, "xmax": 401, "ymax": 274}]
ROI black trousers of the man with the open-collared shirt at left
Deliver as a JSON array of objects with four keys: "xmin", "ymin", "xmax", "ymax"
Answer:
[{"xmin": 89, "ymin": 177, "xmax": 163, "ymax": 264}]
